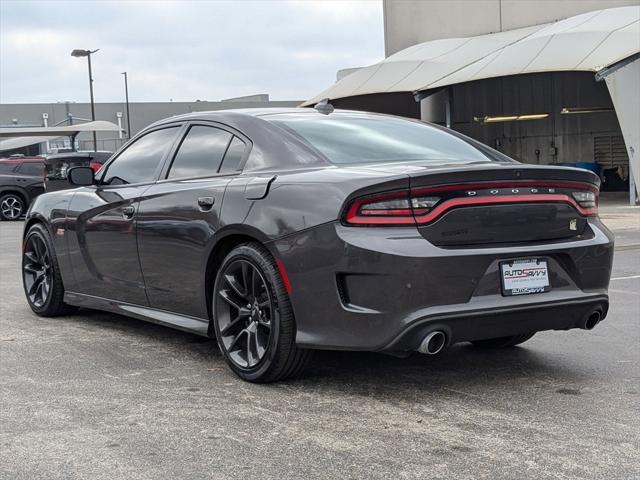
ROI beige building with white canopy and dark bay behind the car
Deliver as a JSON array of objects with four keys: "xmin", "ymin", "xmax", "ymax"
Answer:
[{"xmin": 303, "ymin": 0, "xmax": 640, "ymax": 201}]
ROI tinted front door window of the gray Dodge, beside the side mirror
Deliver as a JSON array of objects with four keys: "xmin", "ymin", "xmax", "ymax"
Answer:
[{"xmin": 102, "ymin": 127, "xmax": 179, "ymax": 185}]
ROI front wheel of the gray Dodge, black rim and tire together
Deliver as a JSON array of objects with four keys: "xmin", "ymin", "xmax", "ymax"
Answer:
[{"xmin": 22, "ymin": 223, "xmax": 77, "ymax": 317}]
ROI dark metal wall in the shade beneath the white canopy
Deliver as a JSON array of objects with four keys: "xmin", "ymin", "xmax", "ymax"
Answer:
[{"xmin": 442, "ymin": 72, "xmax": 622, "ymax": 168}]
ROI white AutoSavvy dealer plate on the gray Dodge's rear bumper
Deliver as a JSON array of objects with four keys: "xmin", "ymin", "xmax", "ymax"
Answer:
[{"xmin": 500, "ymin": 258, "xmax": 551, "ymax": 296}]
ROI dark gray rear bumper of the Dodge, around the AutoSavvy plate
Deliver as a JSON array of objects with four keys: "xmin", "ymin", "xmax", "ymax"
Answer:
[{"xmin": 271, "ymin": 218, "xmax": 613, "ymax": 351}]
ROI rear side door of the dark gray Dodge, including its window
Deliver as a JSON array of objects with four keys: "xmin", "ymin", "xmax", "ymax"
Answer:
[{"xmin": 137, "ymin": 123, "xmax": 249, "ymax": 320}]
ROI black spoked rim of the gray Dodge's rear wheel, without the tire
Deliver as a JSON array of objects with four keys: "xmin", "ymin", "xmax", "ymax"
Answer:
[{"xmin": 217, "ymin": 259, "xmax": 274, "ymax": 368}]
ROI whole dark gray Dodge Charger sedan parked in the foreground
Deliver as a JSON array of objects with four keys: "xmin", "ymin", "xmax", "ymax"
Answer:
[{"xmin": 22, "ymin": 108, "xmax": 613, "ymax": 382}]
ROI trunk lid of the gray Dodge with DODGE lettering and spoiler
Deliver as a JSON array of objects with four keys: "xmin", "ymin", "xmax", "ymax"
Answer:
[{"xmin": 406, "ymin": 164, "xmax": 600, "ymax": 248}]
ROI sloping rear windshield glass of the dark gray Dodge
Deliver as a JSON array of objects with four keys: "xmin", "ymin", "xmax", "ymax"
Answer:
[{"xmin": 263, "ymin": 113, "xmax": 492, "ymax": 164}]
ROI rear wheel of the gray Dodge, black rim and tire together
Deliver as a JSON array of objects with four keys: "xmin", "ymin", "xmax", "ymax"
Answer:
[{"xmin": 213, "ymin": 243, "xmax": 311, "ymax": 383}]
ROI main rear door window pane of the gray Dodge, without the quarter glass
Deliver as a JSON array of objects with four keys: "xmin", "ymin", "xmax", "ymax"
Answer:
[{"xmin": 167, "ymin": 125, "xmax": 233, "ymax": 178}]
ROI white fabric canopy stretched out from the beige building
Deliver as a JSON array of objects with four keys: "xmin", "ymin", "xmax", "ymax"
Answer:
[{"xmin": 302, "ymin": 6, "xmax": 640, "ymax": 106}]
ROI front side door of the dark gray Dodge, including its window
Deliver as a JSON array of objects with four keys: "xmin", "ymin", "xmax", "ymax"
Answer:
[{"xmin": 67, "ymin": 124, "xmax": 182, "ymax": 305}]
